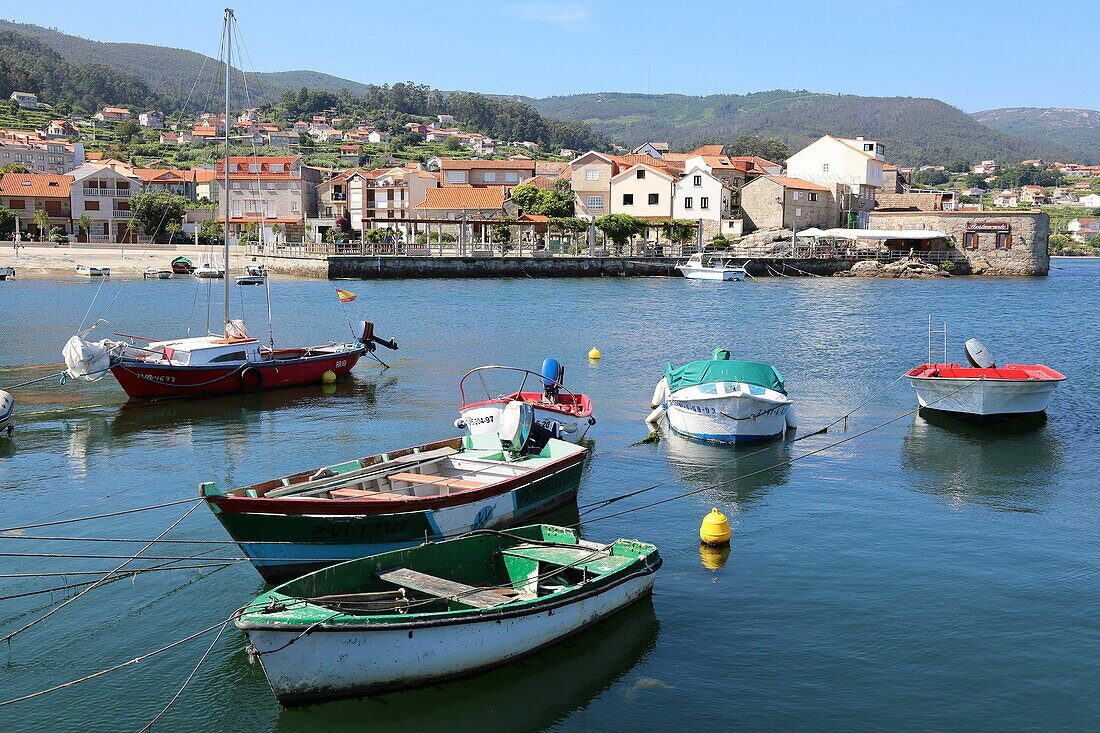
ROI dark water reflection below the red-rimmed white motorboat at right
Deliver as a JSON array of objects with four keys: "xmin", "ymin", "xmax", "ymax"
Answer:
[{"xmin": 902, "ymin": 411, "xmax": 1062, "ymax": 512}]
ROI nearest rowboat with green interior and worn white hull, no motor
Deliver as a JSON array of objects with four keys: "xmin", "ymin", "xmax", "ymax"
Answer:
[{"xmin": 235, "ymin": 525, "xmax": 661, "ymax": 707}]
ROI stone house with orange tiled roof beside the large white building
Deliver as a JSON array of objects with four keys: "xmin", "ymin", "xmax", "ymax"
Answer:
[{"xmin": 741, "ymin": 176, "xmax": 837, "ymax": 230}]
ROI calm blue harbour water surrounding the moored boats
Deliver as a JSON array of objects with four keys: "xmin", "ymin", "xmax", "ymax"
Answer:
[{"xmin": 0, "ymin": 261, "xmax": 1100, "ymax": 732}]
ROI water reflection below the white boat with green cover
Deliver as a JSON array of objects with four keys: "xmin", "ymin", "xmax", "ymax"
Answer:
[{"xmin": 661, "ymin": 428, "xmax": 791, "ymax": 505}]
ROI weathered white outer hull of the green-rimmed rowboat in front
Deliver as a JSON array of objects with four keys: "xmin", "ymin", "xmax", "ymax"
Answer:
[{"xmin": 238, "ymin": 562, "xmax": 660, "ymax": 707}]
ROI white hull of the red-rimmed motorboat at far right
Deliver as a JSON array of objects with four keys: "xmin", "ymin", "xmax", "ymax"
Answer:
[{"xmin": 909, "ymin": 376, "xmax": 1060, "ymax": 417}]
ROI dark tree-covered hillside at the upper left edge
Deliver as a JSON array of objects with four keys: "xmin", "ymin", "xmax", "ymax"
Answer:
[{"xmin": 0, "ymin": 31, "xmax": 164, "ymax": 113}]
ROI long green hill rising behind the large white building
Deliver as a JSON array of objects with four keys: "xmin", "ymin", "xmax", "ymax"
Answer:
[{"xmin": 523, "ymin": 90, "xmax": 1065, "ymax": 165}]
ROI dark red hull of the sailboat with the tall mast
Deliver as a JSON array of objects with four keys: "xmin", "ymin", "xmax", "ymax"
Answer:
[{"xmin": 111, "ymin": 349, "xmax": 364, "ymax": 400}]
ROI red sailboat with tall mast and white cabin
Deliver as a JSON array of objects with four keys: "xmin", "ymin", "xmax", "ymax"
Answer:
[{"xmin": 62, "ymin": 9, "xmax": 397, "ymax": 400}]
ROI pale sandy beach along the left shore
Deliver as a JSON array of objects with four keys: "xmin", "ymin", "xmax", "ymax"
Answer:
[{"xmin": 0, "ymin": 242, "xmax": 260, "ymax": 277}]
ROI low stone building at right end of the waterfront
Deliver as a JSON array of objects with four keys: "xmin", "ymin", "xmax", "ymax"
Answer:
[{"xmin": 868, "ymin": 211, "xmax": 1051, "ymax": 275}]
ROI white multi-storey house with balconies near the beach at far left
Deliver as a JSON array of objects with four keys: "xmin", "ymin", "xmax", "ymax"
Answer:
[{"xmin": 70, "ymin": 163, "xmax": 141, "ymax": 242}]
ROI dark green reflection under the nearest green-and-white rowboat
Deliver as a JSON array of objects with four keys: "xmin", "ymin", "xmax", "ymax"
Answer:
[{"xmin": 264, "ymin": 599, "xmax": 660, "ymax": 733}]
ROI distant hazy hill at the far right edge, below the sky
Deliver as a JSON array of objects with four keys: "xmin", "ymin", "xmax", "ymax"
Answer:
[{"xmin": 970, "ymin": 107, "xmax": 1100, "ymax": 165}]
